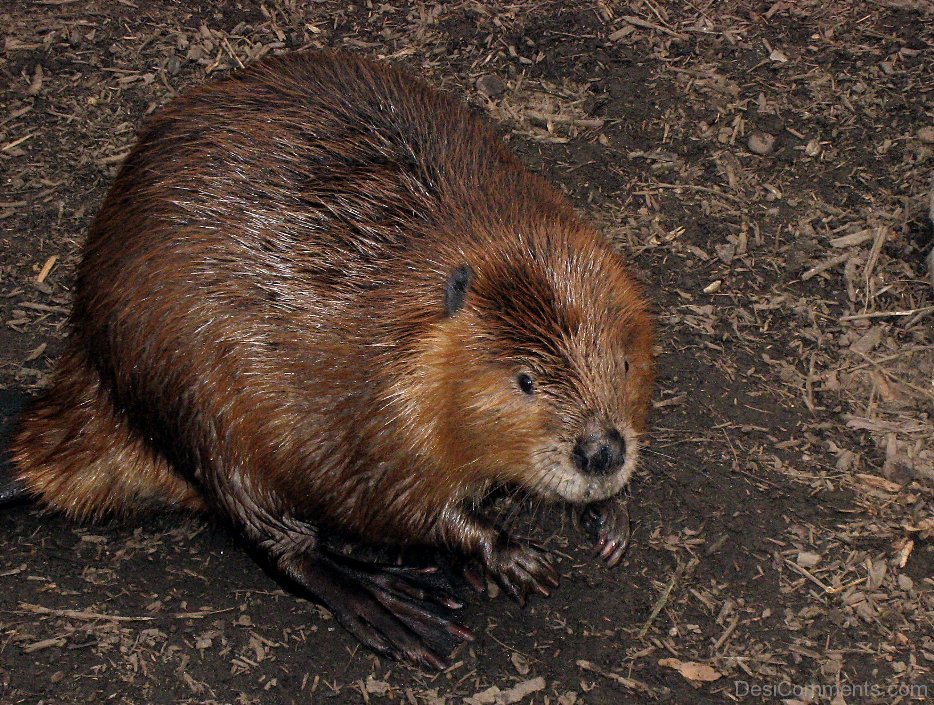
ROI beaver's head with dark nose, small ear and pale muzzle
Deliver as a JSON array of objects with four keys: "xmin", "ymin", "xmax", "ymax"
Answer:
[{"xmin": 420, "ymin": 233, "xmax": 653, "ymax": 503}]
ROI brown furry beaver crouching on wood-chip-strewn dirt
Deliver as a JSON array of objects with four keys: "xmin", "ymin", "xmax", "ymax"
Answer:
[{"xmin": 2, "ymin": 51, "xmax": 653, "ymax": 667}]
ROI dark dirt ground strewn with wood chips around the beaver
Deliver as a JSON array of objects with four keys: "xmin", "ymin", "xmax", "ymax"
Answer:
[{"xmin": 0, "ymin": 0, "xmax": 934, "ymax": 705}]
